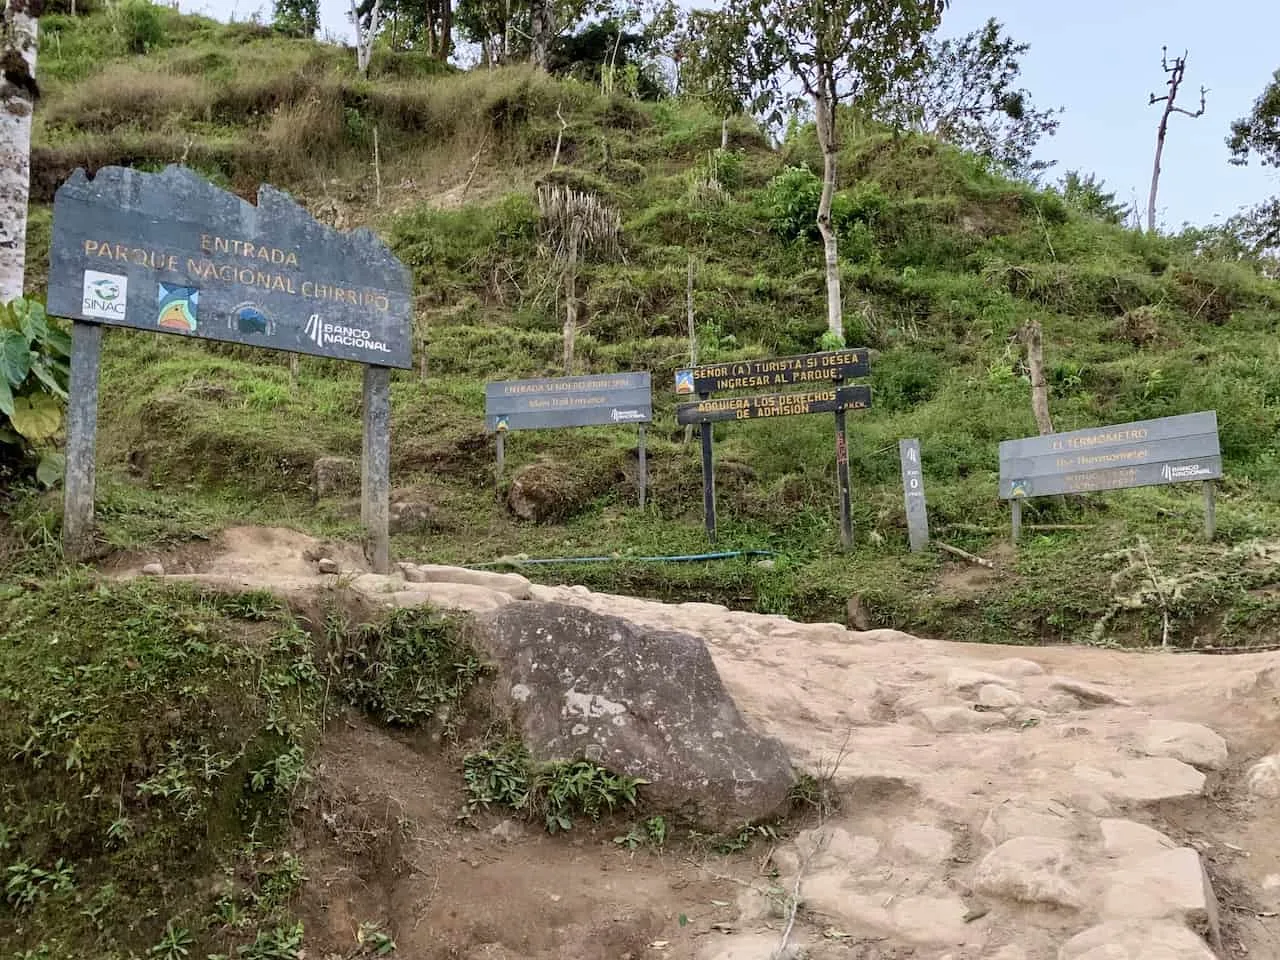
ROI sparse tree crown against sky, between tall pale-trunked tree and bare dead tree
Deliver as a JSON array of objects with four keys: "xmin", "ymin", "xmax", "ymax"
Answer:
[{"xmin": 877, "ymin": 18, "xmax": 1062, "ymax": 177}]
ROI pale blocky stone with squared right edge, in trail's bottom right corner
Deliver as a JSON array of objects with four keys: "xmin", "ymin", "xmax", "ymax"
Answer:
[{"xmin": 1102, "ymin": 846, "xmax": 1220, "ymax": 943}]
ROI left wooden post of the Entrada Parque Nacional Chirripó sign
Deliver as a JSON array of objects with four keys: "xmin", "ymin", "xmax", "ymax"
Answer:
[{"xmin": 63, "ymin": 320, "xmax": 102, "ymax": 559}]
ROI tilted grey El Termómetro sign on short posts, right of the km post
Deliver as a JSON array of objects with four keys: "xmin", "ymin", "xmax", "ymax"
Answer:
[{"xmin": 1000, "ymin": 411, "xmax": 1222, "ymax": 540}]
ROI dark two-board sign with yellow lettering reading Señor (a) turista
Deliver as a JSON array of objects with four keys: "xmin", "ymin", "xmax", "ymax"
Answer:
[{"xmin": 676, "ymin": 347, "xmax": 872, "ymax": 549}]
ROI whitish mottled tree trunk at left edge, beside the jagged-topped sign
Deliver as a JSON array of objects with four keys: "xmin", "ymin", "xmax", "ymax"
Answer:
[{"xmin": 0, "ymin": 0, "xmax": 38, "ymax": 303}]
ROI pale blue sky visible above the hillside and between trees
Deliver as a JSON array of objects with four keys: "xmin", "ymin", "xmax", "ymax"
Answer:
[{"xmin": 179, "ymin": 0, "xmax": 1280, "ymax": 228}]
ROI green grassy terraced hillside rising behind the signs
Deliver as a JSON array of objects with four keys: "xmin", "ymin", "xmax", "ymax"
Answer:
[{"xmin": 9, "ymin": 12, "xmax": 1280, "ymax": 645}]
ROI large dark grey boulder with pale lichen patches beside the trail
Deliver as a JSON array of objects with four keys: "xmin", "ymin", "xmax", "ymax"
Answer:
[{"xmin": 475, "ymin": 600, "xmax": 794, "ymax": 829}]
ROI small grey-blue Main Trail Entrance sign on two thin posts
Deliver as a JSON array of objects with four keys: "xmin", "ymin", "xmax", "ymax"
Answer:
[{"xmin": 484, "ymin": 372, "xmax": 653, "ymax": 509}]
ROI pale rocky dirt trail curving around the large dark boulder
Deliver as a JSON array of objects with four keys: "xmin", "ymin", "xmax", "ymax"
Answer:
[{"xmin": 118, "ymin": 529, "xmax": 1280, "ymax": 960}]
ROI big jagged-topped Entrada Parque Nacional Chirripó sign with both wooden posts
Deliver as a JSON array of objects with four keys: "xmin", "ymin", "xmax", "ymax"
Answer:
[{"xmin": 49, "ymin": 165, "xmax": 412, "ymax": 572}]
